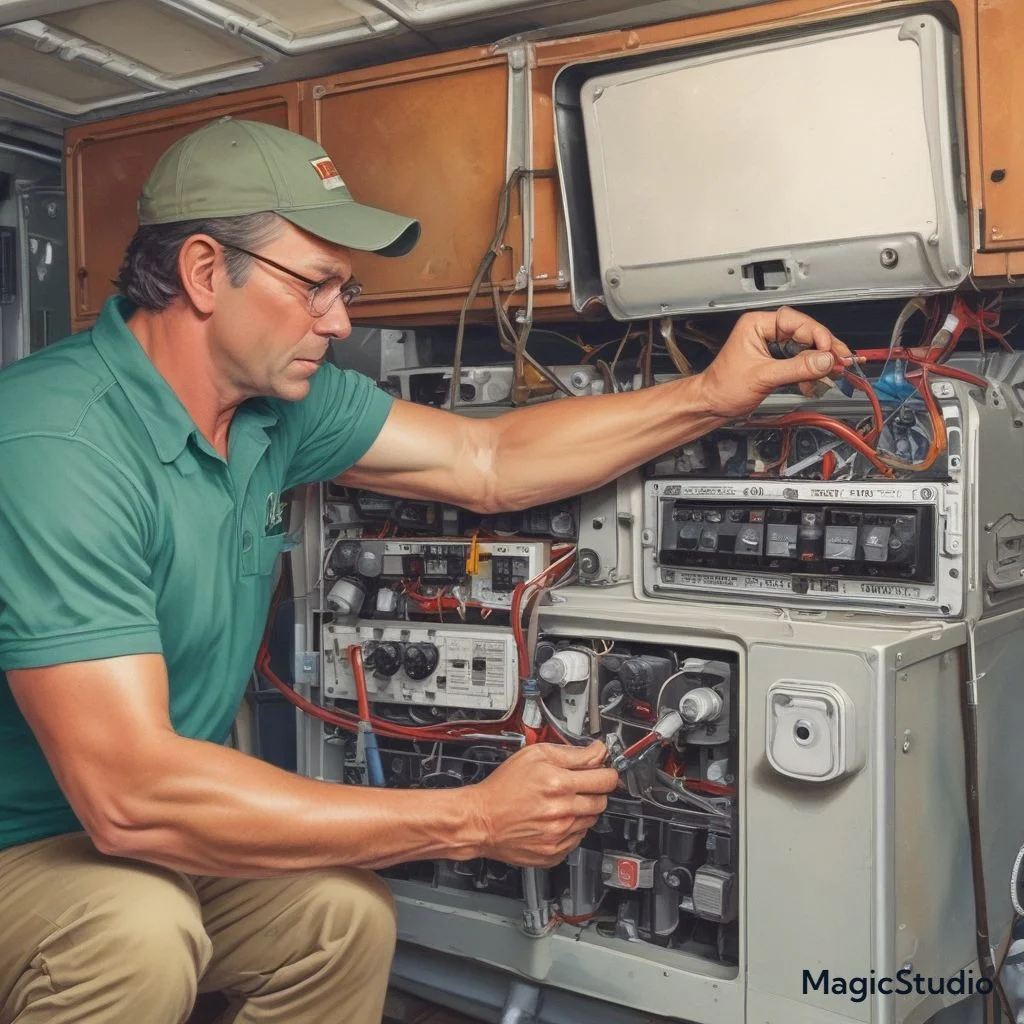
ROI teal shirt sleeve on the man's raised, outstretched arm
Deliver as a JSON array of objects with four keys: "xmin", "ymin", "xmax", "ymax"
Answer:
[{"xmin": 283, "ymin": 364, "xmax": 392, "ymax": 490}]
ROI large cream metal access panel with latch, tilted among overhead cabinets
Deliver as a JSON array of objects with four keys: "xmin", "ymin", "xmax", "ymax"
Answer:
[{"xmin": 580, "ymin": 14, "xmax": 970, "ymax": 319}]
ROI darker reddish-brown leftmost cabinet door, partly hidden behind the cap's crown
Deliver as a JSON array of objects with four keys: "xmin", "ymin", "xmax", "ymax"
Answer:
[{"xmin": 65, "ymin": 83, "xmax": 302, "ymax": 330}]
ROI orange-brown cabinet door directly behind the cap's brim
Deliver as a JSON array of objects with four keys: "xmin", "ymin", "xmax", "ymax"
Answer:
[{"xmin": 307, "ymin": 48, "xmax": 522, "ymax": 322}]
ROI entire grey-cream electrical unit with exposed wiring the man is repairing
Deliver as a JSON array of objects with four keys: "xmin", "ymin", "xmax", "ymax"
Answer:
[{"xmin": 297, "ymin": 274, "xmax": 1024, "ymax": 1024}]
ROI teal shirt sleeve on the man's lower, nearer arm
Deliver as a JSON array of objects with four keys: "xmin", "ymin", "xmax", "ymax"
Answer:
[{"xmin": 0, "ymin": 437, "xmax": 162, "ymax": 672}]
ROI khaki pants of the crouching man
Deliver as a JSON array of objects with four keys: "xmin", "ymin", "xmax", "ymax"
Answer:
[{"xmin": 0, "ymin": 833, "xmax": 395, "ymax": 1024}]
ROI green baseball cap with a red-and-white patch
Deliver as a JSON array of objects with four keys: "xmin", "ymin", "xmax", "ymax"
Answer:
[{"xmin": 138, "ymin": 117, "xmax": 420, "ymax": 256}]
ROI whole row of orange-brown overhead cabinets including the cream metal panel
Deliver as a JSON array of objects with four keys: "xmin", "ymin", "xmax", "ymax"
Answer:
[{"xmin": 59, "ymin": 0, "xmax": 1024, "ymax": 327}]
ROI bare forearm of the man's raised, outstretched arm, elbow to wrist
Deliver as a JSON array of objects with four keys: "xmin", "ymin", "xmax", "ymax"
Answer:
[{"xmin": 493, "ymin": 377, "xmax": 726, "ymax": 510}]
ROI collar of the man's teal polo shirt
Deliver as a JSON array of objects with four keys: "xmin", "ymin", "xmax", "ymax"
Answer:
[{"xmin": 92, "ymin": 295, "xmax": 278, "ymax": 463}]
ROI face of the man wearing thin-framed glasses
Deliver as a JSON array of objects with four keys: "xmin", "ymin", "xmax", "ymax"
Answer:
[{"xmin": 211, "ymin": 221, "xmax": 352, "ymax": 401}]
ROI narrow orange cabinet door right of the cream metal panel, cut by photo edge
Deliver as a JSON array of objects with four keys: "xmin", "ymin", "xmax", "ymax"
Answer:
[{"xmin": 978, "ymin": 0, "xmax": 1024, "ymax": 250}]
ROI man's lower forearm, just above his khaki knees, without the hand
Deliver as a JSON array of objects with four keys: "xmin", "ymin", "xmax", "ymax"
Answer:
[{"xmin": 99, "ymin": 736, "xmax": 483, "ymax": 878}]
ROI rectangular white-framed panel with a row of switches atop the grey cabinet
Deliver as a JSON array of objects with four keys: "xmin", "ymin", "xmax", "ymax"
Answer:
[{"xmin": 643, "ymin": 479, "xmax": 964, "ymax": 615}]
